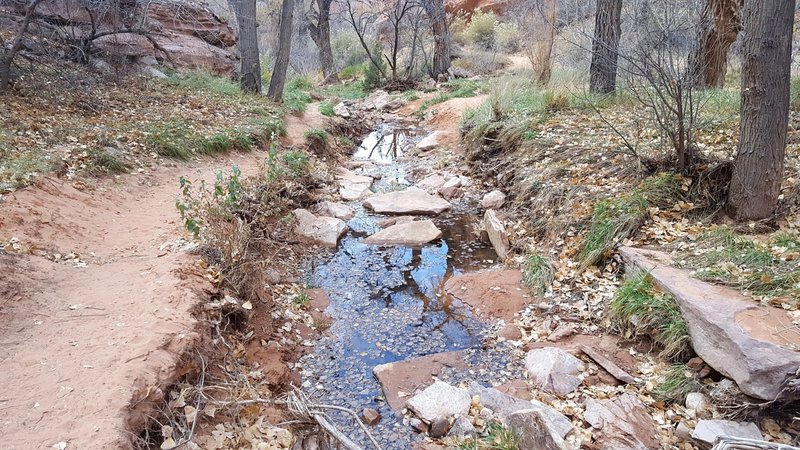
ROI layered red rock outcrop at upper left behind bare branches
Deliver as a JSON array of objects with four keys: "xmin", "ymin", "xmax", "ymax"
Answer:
[{"xmin": 25, "ymin": 0, "xmax": 239, "ymax": 74}]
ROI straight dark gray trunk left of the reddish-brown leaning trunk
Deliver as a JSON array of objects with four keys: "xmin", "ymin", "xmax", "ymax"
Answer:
[{"xmin": 589, "ymin": 0, "xmax": 622, "ymax": 94}]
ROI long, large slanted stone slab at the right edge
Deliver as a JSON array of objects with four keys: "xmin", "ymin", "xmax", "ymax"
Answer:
[{"xmin": 619, "ymin": 247, "xmax": 800, "ymax": 400}]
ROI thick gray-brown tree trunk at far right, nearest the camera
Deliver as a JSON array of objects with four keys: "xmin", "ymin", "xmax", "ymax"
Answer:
[{"xmin": 727, "ymin": 0, "xmax": 795, "ymax": 221}]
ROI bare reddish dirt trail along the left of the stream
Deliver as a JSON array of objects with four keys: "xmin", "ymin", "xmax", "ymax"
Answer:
[{"xmin": 0, "ymin": 154, "xmax": 268, "ymax": 449}]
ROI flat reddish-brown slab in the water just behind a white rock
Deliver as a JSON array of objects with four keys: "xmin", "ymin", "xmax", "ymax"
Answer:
[{"xmin": 372, "ymin": 351, "xmax": 467, "ymax": 411}]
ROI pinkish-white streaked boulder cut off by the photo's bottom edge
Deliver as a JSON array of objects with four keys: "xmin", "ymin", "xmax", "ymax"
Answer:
[{"xmin": 583, "ymin": 394, "xmax": 661, "ymax": 450}]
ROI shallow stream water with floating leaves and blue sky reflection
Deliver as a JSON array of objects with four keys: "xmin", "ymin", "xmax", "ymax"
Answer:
[{"xmin": 302, "ymin": 126, "xmax": 506, "ymax": 449}]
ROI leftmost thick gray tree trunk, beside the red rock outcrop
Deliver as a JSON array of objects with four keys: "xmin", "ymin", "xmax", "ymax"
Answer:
[{"xmin": 229, "ymin": 0, "xmax": 261, "ymax": 94}]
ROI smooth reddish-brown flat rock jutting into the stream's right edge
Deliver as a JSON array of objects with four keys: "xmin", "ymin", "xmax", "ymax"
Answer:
[{"xmin": 444, "ymin": 268, "xmax": 531, "ymax": 323}]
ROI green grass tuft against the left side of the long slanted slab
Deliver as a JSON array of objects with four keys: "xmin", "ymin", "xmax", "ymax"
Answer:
[{"xmin": 609, "ymin": 271, "xmax": 691, "ymax": 360}]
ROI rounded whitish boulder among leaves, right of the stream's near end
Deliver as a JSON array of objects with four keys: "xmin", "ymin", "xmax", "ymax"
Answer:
[{"xmin": 525, "ymin": 347, "xmax": 583, "ymax": 395}]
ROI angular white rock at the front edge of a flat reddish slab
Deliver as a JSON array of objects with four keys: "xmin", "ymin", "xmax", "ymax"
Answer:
[{"xmin": 406, "ymin": 380, "xmax": 472, "ymax": 423}]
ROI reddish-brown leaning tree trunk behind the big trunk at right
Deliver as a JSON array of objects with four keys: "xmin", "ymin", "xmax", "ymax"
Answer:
[{"xmin": 689, "ymin": 0, "xmax": 744, "ymax": 88}]
